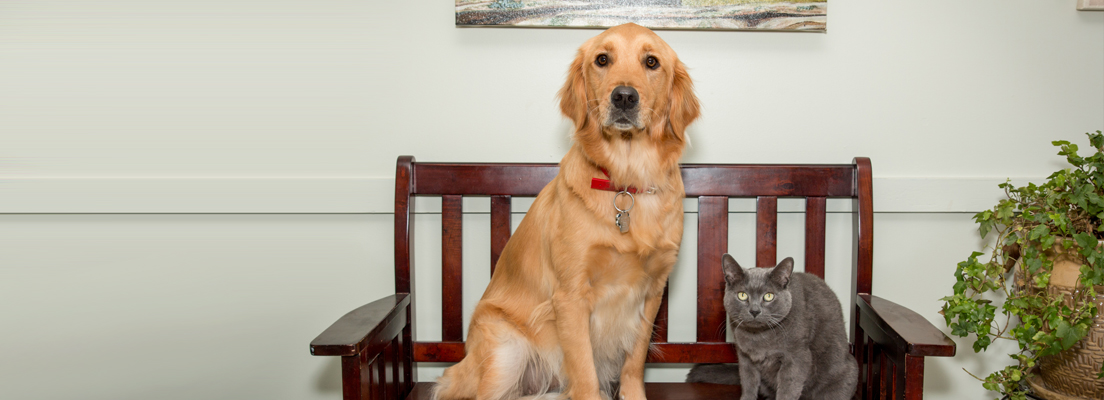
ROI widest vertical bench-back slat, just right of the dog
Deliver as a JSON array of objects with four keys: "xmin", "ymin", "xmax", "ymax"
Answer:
[{"xmin": 698, "ymin": 196, "xmax": 729, "ymax": 341}]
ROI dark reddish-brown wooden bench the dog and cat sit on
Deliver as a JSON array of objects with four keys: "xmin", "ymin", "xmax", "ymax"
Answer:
[{"xmin": 310, "ymin": 156, "xmax": 955, "ymax": 400}]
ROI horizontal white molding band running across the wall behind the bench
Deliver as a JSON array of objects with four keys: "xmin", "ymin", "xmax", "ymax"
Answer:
[{"xmin": 0, "ymin": 177, "xmax": 1043, "ymax": 213}]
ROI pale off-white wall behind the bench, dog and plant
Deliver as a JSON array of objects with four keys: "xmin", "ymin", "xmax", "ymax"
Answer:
[{"xmin": 0, "ymin": 0, "xmax": 1104, "ymax": 399}]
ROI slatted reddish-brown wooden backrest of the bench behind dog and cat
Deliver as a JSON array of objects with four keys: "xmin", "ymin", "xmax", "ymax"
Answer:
[{"xmin": 395, "ymin": 156, "xmax": 873, "ymax": 362}]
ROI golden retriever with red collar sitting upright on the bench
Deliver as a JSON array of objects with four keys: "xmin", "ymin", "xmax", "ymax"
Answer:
[{"xmin": 434, "ymin": 23, "xmax": 699, "ymax": 400}]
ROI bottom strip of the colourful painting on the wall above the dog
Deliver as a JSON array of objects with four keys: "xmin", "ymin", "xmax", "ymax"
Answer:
[{"xmin": 455, "ymin": 0, "xmax": 825, "ymax": 32}]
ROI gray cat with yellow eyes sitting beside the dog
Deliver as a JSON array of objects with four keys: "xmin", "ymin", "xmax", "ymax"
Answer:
[{"xmin": 687, "ymin": 254, "xmax": 859, "ymax": 400}]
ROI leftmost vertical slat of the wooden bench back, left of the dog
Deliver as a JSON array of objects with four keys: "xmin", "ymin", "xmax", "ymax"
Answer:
[{"xmin": 440, "ymin": 194, "xmax": 464, "ymax": 341}]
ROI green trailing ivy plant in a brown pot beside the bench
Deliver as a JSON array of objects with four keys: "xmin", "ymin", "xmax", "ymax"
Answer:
[{"xmin": 941, "ymin": 130, "xmax": 1104, "ymax": 400}]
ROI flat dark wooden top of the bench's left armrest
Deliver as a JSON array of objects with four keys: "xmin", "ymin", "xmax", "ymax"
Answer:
[{"xmin": 310, "ymin": 293, "xmax": 411, "ymax": 356}]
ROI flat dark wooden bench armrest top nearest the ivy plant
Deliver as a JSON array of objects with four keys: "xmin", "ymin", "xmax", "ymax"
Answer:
[{"xmin": 856, "ymin": 294, "xmax": 955, "ymax": 357}]
